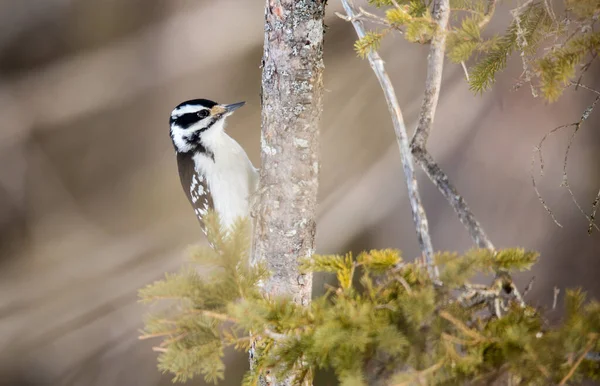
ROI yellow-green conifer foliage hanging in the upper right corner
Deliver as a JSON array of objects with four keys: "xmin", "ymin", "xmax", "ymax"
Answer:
[{"xmin": 355, "ymin": 0, "xmax": 600, "ymax": 102}]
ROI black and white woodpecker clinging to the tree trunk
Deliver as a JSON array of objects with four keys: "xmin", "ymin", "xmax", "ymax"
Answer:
[{"xmin": 169, "ymin": 99, "xmax": 258, "ymax": 234}]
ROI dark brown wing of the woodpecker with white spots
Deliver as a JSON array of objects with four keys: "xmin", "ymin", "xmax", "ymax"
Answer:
[{"xmin": 177, "ymin": 153, "xmax": 214, "ymax": 234}]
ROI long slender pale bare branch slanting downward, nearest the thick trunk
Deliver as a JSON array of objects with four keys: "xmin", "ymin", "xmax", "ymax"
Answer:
[{"xmin": 342, "ymin": 0, "xmax": 436, "ymax": 280}]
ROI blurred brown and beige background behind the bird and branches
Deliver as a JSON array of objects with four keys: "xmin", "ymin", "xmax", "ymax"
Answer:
[{"xmin": 0, "ymin": 0, "xmax": 600, "ymax": 386}]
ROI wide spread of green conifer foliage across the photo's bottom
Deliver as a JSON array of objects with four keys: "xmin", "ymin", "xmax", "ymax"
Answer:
[{"xmin": 140, "ymin": 234, "xmax": 600, "ymax": 386}]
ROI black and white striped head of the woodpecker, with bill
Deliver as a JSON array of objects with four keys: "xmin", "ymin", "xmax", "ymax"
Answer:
[{"xmin": 169, "ymin": 99, "xmax": 246, "ymax": 153}]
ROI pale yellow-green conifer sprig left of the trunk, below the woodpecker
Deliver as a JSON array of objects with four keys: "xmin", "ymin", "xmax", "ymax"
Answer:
[{"xmin": 139, "ymin": 212, "xmax": 268, "ymax": 383}]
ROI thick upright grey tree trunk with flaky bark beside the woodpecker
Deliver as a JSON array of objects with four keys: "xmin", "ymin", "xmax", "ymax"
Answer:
[{"xmin": 252, "ymin": 0, "xmax": 326, "ymax": 384}]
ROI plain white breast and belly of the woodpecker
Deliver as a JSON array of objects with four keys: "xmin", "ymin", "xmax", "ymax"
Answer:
[{"xmin": 194, "ymin": 128, "xmax": 258, "ymax": 229}]
